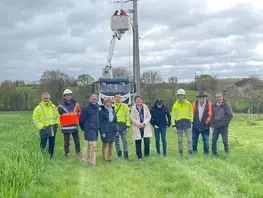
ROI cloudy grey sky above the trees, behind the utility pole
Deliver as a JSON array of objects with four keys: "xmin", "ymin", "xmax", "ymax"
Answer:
[{"xmin": 0, "ymin": 0, "xmax": 263, "ymax": 81}]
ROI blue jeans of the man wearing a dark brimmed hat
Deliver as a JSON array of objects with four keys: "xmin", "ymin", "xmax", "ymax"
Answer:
[{"xmin": 192, "ymin": 128, "xmax": 210, "ymax": 155}]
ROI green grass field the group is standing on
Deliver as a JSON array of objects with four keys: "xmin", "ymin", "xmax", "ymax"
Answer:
[{"xmin": 0, "ymin": 112, "xmax": 263, "ymax": 198}]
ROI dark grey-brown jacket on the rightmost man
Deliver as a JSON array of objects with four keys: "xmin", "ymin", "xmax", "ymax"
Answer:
[{"xmin": 211, "ymin": 100, "xmax": 233, "ymax": 128}]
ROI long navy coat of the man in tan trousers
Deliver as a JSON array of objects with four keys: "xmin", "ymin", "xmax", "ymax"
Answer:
[{"xmin": 79, "ymin": 103, "xmax": 100, "ymax": 141}]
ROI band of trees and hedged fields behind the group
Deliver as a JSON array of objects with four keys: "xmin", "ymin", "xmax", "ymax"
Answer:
[{"xmin": 0, "ymin": 67, "xmax": 263, "ymax": 113}]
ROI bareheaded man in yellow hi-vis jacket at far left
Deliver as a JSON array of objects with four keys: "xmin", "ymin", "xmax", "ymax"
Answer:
[{"xmin": 33, "ymin": 92, "xmax": 59, "ymax": 158}]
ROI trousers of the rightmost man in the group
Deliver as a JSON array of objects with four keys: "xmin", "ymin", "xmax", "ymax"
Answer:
[{"xmin": 212, "ymin": 126, "xmax": 229, "ymax": 155}]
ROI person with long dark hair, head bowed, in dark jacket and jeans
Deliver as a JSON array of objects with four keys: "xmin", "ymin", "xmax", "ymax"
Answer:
[{"xmin": 151, "ymin": 98, "xmax": 171, "ymax": 157}]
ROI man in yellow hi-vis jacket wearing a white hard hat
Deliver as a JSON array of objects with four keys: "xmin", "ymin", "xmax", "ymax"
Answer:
[{"xmin": 172, "ymin": 89, "xmax": 193, "ymax": 155}]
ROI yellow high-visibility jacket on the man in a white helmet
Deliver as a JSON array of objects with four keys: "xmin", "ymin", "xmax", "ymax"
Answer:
[{"xmin": 172, "ymin": 100, "xmax": 193, "ymax": 127}]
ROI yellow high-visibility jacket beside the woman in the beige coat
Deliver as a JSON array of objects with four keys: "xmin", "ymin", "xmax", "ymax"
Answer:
[{"xmin": 113, "ymin": 102, "xmax": 131, "ymax": 127}]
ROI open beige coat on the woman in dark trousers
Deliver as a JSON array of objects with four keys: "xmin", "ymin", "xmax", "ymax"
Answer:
[{"xmin": 131, "ymin": 104, "xmax": 152, "ymax": 140}]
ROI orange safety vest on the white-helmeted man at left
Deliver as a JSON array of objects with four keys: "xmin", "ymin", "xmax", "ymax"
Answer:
[{"xmin": 59, "ymin": 103, "xmax": 80, "ymax": 127}]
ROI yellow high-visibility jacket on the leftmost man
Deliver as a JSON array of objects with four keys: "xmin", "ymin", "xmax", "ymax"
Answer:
[{"xmin": 33, "ymin": 101, "xmax": 59, "ymax": 130}]
